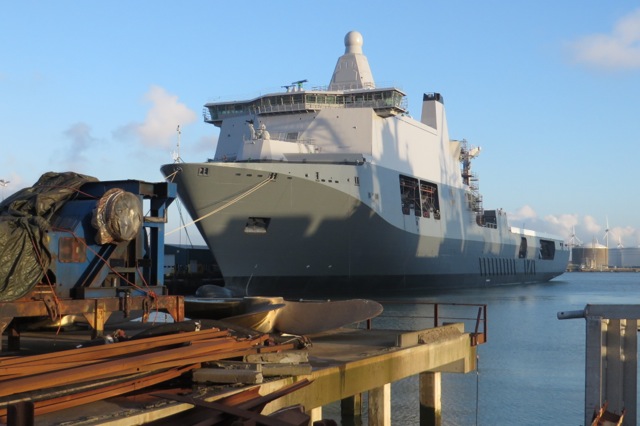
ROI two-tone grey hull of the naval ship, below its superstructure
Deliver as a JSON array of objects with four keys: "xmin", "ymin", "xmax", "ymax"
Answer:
[{"xmin": 162, "ymin": 162, "xmax": 568, "ymax": 298}]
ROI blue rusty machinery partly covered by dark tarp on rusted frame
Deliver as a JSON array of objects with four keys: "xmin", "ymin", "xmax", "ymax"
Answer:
[{"xmin": 0, "ymin": 173, "xmax": 184, "ymax": 349}]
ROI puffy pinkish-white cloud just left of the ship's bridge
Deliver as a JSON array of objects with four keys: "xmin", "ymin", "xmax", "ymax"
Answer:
[{"xmin": 114, "ymin": 86, "xmax": 197, "ymax": 149}]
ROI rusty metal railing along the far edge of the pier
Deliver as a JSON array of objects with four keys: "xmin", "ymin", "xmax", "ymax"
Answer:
[{"xmin": 367, "ymin": 299, "xmax": 487, "ymax": 346}]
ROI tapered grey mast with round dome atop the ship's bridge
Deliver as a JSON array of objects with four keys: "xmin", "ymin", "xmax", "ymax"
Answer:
[{"xmin": 329, "ymin": 31, "xmax": 375, "ymax": 90}]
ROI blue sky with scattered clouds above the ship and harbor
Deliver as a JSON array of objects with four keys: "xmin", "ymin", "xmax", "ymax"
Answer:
[{"xmin": 0, "ymin": 0, "xmax": 640, "ymax": 247}]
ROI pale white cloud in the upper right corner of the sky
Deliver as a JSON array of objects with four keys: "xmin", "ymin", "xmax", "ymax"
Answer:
[{"xmin": 568, "ymin": 9, "xmax": 640, "ymax": 70}]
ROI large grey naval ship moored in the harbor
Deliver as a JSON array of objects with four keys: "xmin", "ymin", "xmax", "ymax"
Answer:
[{"xmin": 161, "ymin": 31, "xmax": 569, "ymax": 298}]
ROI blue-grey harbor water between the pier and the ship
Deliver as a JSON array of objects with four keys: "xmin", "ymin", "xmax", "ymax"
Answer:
[{"xmin": 325, "ymin": 272, "xmax": 640, "ymax": 426}]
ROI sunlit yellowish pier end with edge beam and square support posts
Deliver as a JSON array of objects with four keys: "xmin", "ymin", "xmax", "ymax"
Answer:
[{"xmin": 258, "ymin": 324, "xmax": 476, "ymax": 425}]
